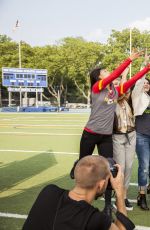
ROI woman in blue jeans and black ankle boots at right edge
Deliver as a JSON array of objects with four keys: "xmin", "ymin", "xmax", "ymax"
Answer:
[{"xmin": 132, "ymin": 63, "xmax": 150, "ymax": 210}]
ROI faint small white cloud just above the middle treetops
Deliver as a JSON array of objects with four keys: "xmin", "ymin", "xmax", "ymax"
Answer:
[{"xmin": 83, "ymin": 28, "xmax": 108, "ymax": 42}]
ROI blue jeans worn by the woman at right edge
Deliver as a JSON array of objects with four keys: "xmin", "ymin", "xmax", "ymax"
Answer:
[{"xmin": 136, "ymin": 133, "xmax": 150, "ymax": 187}]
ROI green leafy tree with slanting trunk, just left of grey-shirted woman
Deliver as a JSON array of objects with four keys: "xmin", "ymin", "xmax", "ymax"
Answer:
[{"xmin": 58, "ymin": 38, "xmax": 103, "ymax": 105}]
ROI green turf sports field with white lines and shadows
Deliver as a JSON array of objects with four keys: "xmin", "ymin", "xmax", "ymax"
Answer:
[{"xmin": 0, "ymin": 113, "xmax": 150, "ymax": 230}]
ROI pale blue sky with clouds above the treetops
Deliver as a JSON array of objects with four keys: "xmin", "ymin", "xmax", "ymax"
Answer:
[{"xmin": 0, "ymin": 0, "xmax": 150, "ymax": 46}]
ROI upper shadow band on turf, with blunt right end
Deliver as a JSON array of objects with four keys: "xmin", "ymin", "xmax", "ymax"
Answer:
[{"xmin": 0, "ymin": 151, "xmax": 57, "ymax": 192}]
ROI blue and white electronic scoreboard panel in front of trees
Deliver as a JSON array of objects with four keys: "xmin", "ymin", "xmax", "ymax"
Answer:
[{"xmin": 2, "ymin": 67, "xmax": 47, "ymax": 88}]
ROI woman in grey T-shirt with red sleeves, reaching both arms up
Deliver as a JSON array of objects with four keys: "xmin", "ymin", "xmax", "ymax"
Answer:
[{"xmin": 70, "ymin": 52, "xmax": 150, "ymax": 215}]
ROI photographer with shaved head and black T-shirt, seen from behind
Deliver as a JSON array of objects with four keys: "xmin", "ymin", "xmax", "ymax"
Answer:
[{"xmin": 23, "ymin": 156, "xmax": 133, "ymax": 230}]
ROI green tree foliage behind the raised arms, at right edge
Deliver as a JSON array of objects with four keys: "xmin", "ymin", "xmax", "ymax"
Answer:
[{"xmin": 103, "ymin": 29, "xmax": 150, "ymax": 74}]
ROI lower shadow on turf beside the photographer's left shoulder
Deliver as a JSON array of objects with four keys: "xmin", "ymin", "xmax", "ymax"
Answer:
[{"xmin": 0, "ymin": 172, "xmax": 74, "ymax": 230}]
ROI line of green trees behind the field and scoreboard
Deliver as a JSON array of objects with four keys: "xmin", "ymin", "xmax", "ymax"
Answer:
[{"xmin": 0, "ymin": 28, "xmax": 150, "ymax": 107}]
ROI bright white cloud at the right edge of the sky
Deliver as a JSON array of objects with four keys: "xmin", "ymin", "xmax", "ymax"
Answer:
[{"xmin": 129, "ymin": 17, "xmax": 150, "ymax": 31}]
